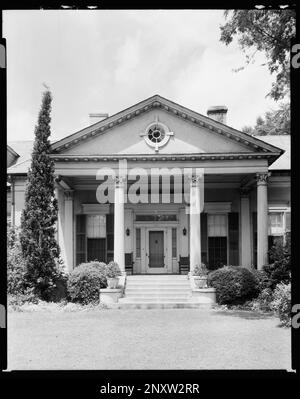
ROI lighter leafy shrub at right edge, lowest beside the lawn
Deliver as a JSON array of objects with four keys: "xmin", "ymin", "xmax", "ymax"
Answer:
[{"xmin": 271, "ymin": 283, "xmax": 292, "ymax": 326}]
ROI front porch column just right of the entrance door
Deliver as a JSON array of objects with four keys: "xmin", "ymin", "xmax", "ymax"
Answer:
[{"xmin": 190, "ymin": 176, "xmax": 201, "ymax": 274}]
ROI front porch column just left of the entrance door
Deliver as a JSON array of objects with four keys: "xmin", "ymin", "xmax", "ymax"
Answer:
[{"xmin": 114, "ymin": 176, "xmax": 125, "ymax": 273}]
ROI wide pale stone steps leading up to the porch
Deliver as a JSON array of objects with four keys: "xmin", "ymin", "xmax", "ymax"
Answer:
[{"xmin": 118, "ymin": 274, "xmax": 201, "ymax": 309}]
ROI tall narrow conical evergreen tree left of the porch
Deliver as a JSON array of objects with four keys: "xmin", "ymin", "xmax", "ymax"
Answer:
[{"xmin": 20, "ymin": 90, "xmax": 60, "ymax": 300}]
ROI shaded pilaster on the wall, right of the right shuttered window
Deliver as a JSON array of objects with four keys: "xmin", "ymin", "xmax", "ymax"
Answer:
[{"xmin": 241, "ymin": 188, "xmax": 252, "ymax": 268}]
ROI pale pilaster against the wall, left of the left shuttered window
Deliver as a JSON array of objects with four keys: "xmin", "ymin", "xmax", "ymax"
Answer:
[{"xmin": 64, "ymin": 190, "xmax": 74, "ymax": 272}]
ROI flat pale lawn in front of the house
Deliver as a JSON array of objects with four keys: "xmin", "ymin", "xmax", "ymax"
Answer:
[{"xmin": 8, "ymin": 309, "xmax": 291, "ymax": 370}]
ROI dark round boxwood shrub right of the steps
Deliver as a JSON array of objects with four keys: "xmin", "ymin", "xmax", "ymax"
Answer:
[{"xmin": 208, "ymin": 266, "xmax": 259, "ymax": 305}]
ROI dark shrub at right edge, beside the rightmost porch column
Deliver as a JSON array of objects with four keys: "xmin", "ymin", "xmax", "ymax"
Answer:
[{"xmin": 263, "ymin": 237, "xmax": 291, "ymax": 290}]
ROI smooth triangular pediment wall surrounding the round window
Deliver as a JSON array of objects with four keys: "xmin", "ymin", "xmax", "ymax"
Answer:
[{"xmin": 64, "ymin": 110, "xmax": 250, "ymax": 155}]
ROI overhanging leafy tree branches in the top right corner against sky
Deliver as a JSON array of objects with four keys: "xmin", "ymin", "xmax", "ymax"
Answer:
[{"xmin": 220, "ymin": 10, "xmax": 296, "ymax": 101}]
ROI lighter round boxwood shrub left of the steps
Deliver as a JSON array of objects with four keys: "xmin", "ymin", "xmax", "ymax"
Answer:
[{"xmin": 67, "ymin": 262, "xmax": 107, "ymax": 304}]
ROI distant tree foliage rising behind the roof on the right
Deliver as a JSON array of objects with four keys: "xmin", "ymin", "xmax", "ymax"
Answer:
[{"xmin": 242, "ymin": 103, "xmax": 291, "ymax": 136}]
